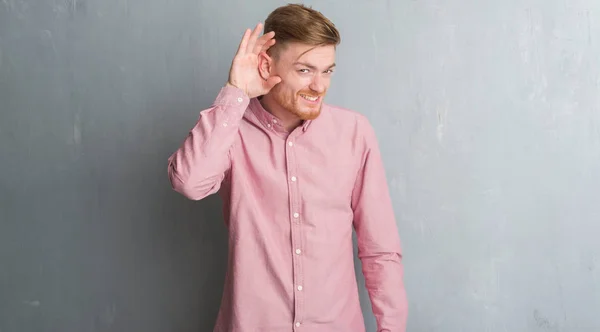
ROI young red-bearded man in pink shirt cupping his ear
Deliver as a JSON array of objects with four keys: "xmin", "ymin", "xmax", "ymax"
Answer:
[{"xmin": 168, "ymin": 5, "xmax": 407, "ymax": 332}]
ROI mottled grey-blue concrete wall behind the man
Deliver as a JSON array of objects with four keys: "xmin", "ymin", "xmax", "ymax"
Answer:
[{"xmin": 0, "ymin": 0, "xmax": 600, "ymax": 332}]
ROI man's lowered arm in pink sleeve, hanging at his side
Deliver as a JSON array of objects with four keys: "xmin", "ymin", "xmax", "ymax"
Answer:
[{"xmin": 352, "ymin": 116, "xmax": 408, "ymax": 332}]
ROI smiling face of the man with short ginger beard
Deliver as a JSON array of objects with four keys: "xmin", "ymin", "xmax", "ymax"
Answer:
[{"xmin": 269, "ymin": 43, "xmax": 335, "ymax": 120}]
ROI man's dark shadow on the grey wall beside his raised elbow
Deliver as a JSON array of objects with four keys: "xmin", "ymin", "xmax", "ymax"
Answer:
[{"xmin": 140, "ymin": 96, "xmax": 228, "ymax": 331}]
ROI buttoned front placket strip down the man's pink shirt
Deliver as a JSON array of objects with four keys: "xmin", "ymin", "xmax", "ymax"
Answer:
[{"xmin": 285, "ymin": 133, "xmax": 304, "ymax": 327}]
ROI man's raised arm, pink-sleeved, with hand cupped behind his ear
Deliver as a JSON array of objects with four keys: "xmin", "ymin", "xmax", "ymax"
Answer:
[{"xmin": 168, "ymin": 23, "xmax": 281, "ymax": 200}]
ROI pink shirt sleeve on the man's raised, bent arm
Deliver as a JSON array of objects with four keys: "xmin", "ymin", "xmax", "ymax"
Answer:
[{"xmin": 168, "ymin": 86, "xmax": 250, "ymax": 200}]
